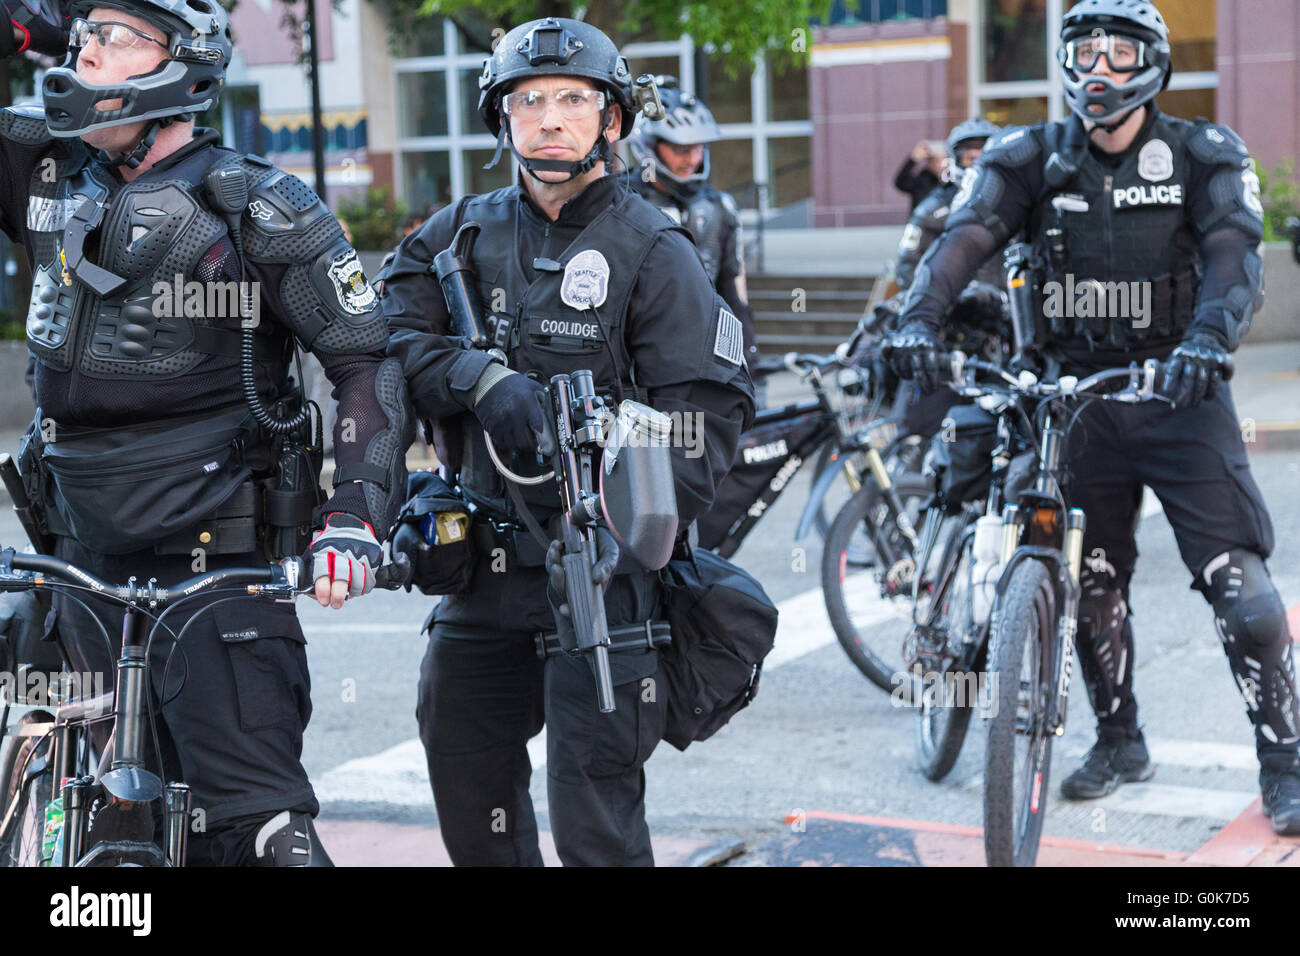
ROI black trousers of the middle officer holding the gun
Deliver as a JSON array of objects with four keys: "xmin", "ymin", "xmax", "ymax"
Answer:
[{"xmin": 416, "ymin": 555, "xmax": 667, "ymax": 866}]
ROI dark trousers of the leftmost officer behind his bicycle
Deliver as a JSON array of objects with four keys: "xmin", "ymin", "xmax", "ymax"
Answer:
[{"xmin": 53, "ymin": 538, "xmax": 320, "ymax": 866}]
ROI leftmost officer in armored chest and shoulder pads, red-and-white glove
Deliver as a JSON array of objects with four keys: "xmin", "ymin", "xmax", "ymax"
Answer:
[{"xmin": 0, "ymin": 0, "xmax": 412, "ymax": 866}]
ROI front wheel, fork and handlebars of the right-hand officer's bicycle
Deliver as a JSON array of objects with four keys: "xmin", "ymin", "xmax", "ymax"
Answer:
[{"xmin": 944, "ymin": 352, "xmax": 1190, "ymax": 866}]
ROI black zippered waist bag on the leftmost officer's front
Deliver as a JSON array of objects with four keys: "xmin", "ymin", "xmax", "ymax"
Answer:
[{"xmin": 35, "ymin": 403, "xmax": 257, "ymax": 554}]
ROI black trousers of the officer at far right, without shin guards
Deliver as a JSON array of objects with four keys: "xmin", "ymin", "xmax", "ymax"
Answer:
[{"xmin": 1066, "ymin": 385, "xmax": 1295, "ymax": 756}]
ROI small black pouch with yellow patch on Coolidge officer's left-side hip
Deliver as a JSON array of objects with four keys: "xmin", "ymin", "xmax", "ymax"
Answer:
[{"xmin": 390, "ymin": 471, "xmax": 476, "ymax": 594}]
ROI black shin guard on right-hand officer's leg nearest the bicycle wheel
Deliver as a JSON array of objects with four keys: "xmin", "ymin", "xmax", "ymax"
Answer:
[{"xmin": 1075, "ymin": 567, "xmax": 1134, "ymax": 718}]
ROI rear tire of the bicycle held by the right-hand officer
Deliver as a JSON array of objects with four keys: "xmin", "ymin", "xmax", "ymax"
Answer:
[{"xmin": 917, "ymin": 536, "xmax": 978, "ymax": 783}]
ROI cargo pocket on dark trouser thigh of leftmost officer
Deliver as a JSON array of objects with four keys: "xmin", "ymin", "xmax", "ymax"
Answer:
[{"xmin": 211, "ymin": 601, "xmax": 312, "ymax": 732}]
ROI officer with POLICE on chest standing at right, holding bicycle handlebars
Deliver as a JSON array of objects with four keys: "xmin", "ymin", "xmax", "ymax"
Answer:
[{"xmin": 893, "ymin": 0, "xmax": 1300, "ymax": 834}]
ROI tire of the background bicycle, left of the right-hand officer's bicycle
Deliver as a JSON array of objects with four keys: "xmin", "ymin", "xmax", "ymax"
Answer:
[{"xmin": 822, "ymin": 475, "xmax": 932, "ymax": 702}]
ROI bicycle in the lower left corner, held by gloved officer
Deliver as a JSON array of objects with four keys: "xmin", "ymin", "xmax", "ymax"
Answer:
[{"xmin": 0, "ymin": 549, "xmax": 411, "ymax": 866}]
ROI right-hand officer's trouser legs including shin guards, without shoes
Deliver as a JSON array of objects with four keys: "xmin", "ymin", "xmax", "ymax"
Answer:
[{"xmin": 1066, "ymin": 385, "xmax": 1296, "ymax": 760}]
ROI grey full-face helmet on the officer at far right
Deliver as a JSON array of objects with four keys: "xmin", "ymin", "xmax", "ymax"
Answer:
[{"xmin": 1057, "ymin": 0, "xmax": 1171, "ymax": 130}]
